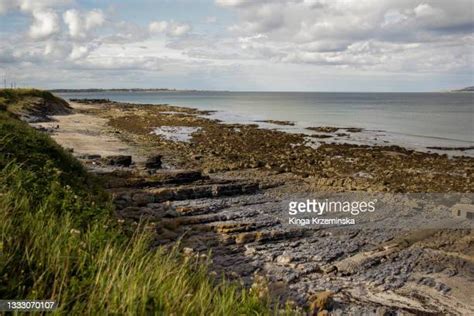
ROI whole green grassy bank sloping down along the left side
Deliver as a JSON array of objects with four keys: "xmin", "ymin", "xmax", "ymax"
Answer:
[{"xmin": 0, "ymin": 90, "xmax": 272, "ymax": 315}]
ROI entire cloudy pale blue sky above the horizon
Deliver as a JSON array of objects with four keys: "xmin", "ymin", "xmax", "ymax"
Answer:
[{"xmin": 0, "ymin": 0, "xmax": 474, "ymax": 92}]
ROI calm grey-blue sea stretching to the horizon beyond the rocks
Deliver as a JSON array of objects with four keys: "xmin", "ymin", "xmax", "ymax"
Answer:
[{"xmin": 56, "ymin": 90, "xmax": 474, "ymax": 157}]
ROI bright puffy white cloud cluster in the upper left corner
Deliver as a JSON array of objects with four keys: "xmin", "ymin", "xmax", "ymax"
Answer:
[{"xmin": 0, "ymin": 0, "xmax": 105, "ymax": 66}]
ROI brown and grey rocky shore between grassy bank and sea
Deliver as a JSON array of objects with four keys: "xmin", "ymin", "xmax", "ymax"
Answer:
[{"xmin": 36, "ymin": 100, "xmax": 474, "ymax": 315}]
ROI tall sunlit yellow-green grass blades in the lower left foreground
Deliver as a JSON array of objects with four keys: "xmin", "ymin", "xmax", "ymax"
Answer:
[{"xmin": 0, "ymin": 164, "xmax": 269, "ymax": 315}]
